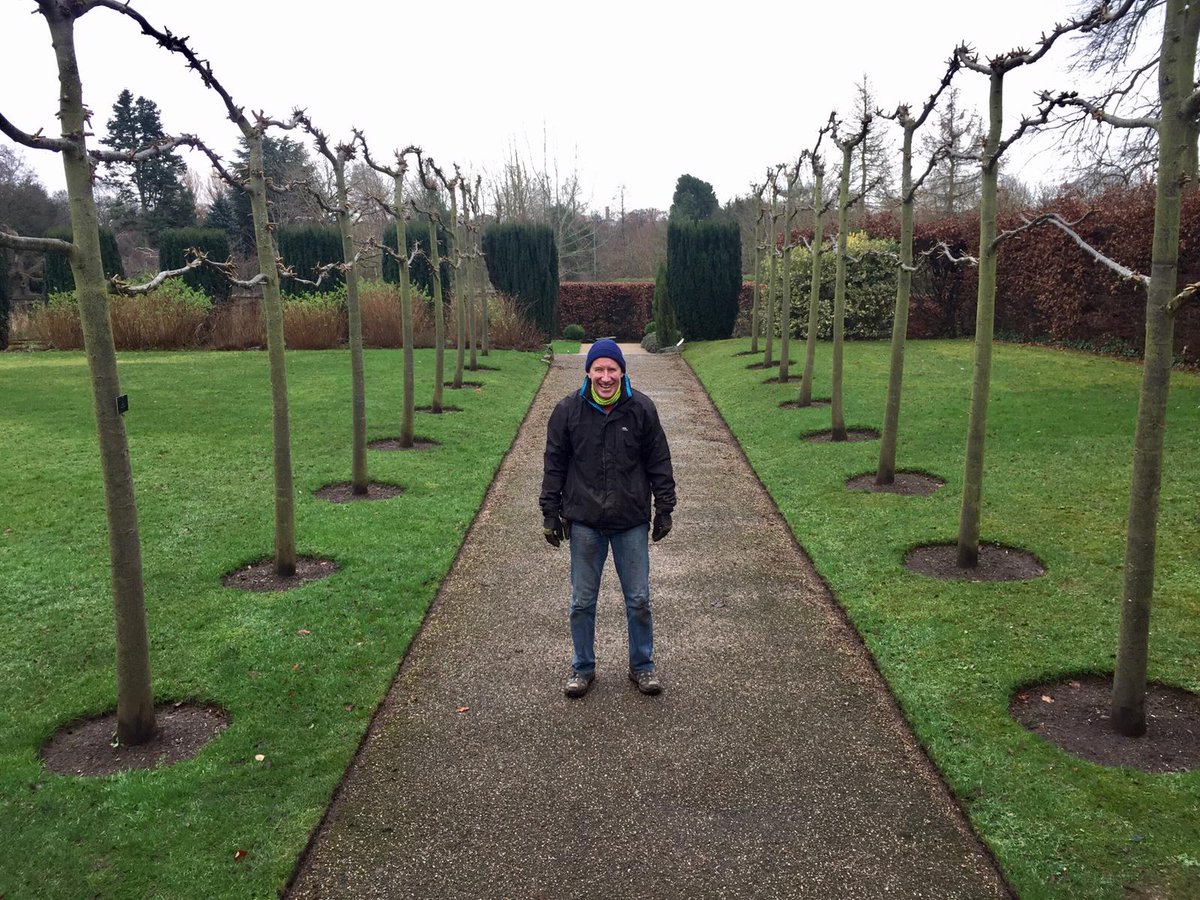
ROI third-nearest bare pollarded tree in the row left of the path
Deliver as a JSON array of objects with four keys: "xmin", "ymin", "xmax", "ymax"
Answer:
[{"xmin": 293, "ymin": 110, "xmax": 371, "ymax": 497}]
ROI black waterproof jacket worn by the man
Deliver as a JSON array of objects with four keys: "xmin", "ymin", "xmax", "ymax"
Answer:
[{"xmin": 539, "ymin": 377, "xmax": 676, "ymax": 532}]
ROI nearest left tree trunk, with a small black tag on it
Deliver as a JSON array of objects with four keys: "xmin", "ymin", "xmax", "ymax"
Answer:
[{"xmin": 41, "ymin": 5, "xmax": 155, "ymax": 744}]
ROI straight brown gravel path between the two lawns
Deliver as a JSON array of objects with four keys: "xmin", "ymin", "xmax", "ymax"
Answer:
[{"xmin": 289, "ymin": 354, "xmax": 1007, "ymax": 900}]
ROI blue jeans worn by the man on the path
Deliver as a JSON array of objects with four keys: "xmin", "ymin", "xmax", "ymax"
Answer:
[{"xmin": 571, "ymin": 522, "xmax": 654, "ymax": 674}]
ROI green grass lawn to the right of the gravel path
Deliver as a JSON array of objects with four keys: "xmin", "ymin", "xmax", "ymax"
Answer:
[{"xmin": 685, "ymin": 340, "xmax": 1200, "ymax": 900}]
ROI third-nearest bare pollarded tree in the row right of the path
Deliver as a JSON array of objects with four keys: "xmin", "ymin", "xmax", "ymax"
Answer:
[{"xmin": 875, "ymin": 56, "xmax": 959, "ymax": 485}]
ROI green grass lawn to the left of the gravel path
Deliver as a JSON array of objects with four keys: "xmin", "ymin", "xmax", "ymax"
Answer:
[{"xmin": 0, "ymin": 350, "xmax": 546, "ymax": 898}]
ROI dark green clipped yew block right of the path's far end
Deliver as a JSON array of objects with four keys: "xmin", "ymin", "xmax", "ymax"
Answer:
[{"xmin": 667, "ymin": 221, "xmax": 742, "ymax": 341}]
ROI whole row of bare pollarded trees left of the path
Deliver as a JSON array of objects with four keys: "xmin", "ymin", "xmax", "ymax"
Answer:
[{"xmin": 0, "ymin": 0, "xmax": 488, "ymax": 744}]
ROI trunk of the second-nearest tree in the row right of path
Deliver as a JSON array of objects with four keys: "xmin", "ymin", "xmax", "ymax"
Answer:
[{"xmin": 958, "ymin": 71, "xmax": 1004, "ymax": 569}]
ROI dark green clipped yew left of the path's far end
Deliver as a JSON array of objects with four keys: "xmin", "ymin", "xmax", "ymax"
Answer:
[{"xmin": 484, "ymin": 222, "xmax": 556, "ymax": 337}]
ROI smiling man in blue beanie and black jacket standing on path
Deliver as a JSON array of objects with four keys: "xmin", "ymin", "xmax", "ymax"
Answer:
[{"xmin": 539, "ymin": 340, "xmax": 676, "ymax": 697}]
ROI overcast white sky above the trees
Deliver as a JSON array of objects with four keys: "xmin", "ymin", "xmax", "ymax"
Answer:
[{"xmin": 0, "ymin": 0, "xmax": 1123, "ymax": 211}]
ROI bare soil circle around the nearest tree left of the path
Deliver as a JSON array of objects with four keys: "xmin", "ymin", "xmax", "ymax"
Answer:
[{"xmin": 42, "ymin": 703, "xmax": 229, "ymax": 778}]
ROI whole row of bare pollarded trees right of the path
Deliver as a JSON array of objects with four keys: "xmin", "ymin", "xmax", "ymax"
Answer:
[{"xmin": 751, "ymin": 0, "xmax": 1200, "ymax": 736}]
